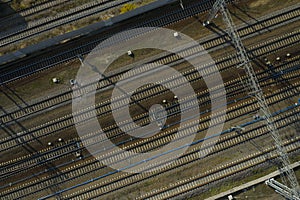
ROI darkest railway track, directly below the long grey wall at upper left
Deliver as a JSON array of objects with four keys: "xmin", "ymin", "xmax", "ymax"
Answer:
[{"xmin": 0, "ymin": 0, "xmax": 211, "ymax": 84}]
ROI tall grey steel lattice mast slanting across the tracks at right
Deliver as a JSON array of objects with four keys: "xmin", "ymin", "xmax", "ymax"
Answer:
[{"xmin": 203, "ymin": 0, "xmax": 300, "ymax": 200}]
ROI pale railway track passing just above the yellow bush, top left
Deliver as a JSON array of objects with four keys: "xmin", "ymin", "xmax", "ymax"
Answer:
[{"xmin": 0, "ymin": 0, "xmax": 132, "ymax": 47}]
